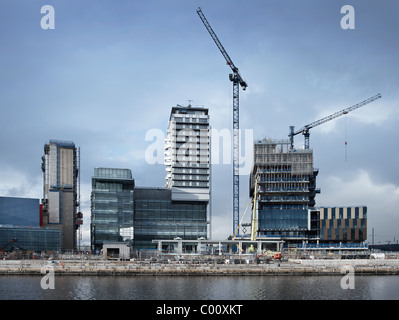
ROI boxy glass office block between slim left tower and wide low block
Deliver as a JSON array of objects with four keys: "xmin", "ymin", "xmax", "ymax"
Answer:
[{"xmin": 90, "ymin": 168, "xmax": 134, "ymax": 250}]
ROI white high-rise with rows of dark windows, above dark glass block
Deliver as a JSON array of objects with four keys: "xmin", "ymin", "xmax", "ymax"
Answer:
[{"xmin": 165, "ymin": 106, "xmax": 210, "ymax": 202}]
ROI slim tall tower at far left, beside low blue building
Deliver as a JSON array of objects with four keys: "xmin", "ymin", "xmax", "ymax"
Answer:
[{"xmin": 42, "ymin": 140, "xmax": 79, "ymax": 250}]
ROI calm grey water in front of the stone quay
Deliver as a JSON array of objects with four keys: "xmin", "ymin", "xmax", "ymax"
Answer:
[{"xmin": 0, "ymin": 275, "xmax": 399, "ymax": 300}]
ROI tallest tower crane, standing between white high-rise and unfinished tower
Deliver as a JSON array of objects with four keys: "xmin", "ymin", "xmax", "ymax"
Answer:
[{"xmin": 197, "ymin": 7, "xmax": 248, "ymax": 234}]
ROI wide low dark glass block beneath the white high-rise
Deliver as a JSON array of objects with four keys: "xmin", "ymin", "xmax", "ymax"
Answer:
[{"xmin": 134, "ymin": 188, "xmax": 207, "ymax": 249}]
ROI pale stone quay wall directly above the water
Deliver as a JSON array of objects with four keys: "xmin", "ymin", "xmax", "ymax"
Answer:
[{"xmin": 0, "ymin": 259, "xmax": 399, "ymax": 276}]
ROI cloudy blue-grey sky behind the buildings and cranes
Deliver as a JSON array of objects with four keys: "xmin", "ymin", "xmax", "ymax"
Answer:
[{"xmin": 0, "ymin": 0, "xmax": 399, "ymax": 243}]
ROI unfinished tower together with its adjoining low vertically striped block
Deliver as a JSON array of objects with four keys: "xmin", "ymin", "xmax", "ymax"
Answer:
[{"xmin": 250, "ymin": 139, "xmax": 367, "ymax": 249}]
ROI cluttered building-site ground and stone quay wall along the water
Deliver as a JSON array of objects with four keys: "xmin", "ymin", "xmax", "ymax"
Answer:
[{"xmin": 0, "ymin": 246, "xmax": 399, "ymax": 276}]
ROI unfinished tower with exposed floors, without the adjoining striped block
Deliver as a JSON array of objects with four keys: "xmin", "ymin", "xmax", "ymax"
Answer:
[{"xmin": 250, "ymin": 139, "xmax": 320, "ymax": 241}]
